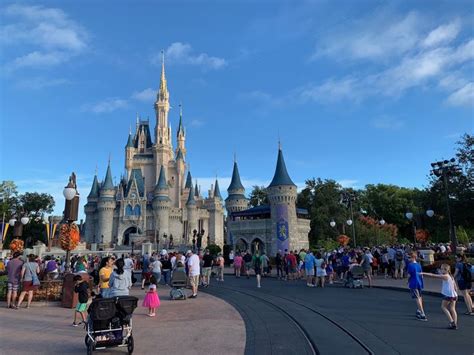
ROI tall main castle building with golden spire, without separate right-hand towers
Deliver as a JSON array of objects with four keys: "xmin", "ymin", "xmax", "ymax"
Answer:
[{"xmin": 84, "ymin": 56, "xmax": 224, "ymax": 247}]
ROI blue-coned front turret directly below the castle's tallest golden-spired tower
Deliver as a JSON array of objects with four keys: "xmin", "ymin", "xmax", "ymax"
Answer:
[{"xmin": 153, "ymin": 165, "xmax": 171, "ymax": 240}]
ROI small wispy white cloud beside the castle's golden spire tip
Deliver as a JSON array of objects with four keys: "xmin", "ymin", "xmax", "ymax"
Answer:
[{"xmin": 152, "ymin": 42, "xmax": 227, "ymax": 70}]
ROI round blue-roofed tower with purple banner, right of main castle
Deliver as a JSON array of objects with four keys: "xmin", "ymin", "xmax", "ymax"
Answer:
[{"xmin": 267, "ymin": 147, "xmax": 296, "ymax": 255}]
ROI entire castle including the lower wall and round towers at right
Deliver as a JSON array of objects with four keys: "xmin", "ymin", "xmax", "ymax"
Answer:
[{"xmin": 84, "ymin": 55, "xmax": 310, "ymax": 255}]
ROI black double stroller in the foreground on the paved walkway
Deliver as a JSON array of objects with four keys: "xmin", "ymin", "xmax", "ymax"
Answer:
[{"xmin": 85, "ymin": 296, "xmax": 138, "ymax": 355}]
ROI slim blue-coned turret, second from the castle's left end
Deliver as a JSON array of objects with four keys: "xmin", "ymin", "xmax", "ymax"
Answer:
[{"xmin": 97, "ymin": 161, "xmax": 116, "ymax": 244}]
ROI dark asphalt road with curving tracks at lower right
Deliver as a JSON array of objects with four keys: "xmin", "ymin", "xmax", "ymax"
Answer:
[{"xmin": 205, "ymin": 276, "xmax": 474, "ymax": 355}]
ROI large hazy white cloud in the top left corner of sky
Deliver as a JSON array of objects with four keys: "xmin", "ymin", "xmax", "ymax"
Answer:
[{"xmin": 0, "ymin": 4, "xmax": 88, "ymax": 71}]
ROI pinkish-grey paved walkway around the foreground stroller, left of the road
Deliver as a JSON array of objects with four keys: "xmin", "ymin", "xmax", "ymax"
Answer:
[{"xmin": 0, "ymin": 286, "xmax": 246, "ymax": 355}]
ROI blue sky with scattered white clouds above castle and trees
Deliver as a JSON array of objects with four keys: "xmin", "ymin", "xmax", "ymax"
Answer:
[{"xmin": 0, "ymin": 0, "xmax": 474, "ymax": 220}]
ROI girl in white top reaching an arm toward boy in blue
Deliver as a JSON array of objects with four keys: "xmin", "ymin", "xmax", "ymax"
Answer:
[{"xmin": 421, "ymin": 264, "xmax": 458, "ymax": 329}]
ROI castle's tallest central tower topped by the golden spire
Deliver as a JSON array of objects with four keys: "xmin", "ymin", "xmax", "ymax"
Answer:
[{"xmin": 154, "ymin": 50, "xmax": 173, "ymax": 182}]
